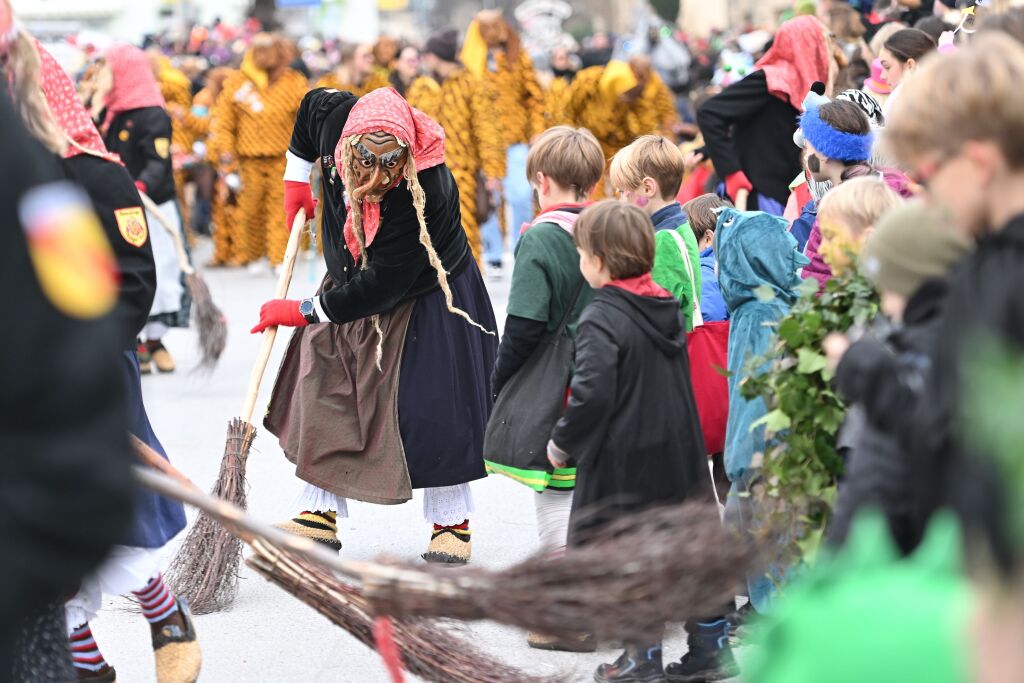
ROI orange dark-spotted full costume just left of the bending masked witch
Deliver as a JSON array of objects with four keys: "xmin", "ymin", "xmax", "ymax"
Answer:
[{"xmin": 210, "ymin": 53, "xmax": 308, "ymax": 264}]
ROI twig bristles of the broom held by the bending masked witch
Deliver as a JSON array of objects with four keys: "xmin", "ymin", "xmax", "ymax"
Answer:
[{"xmin": 167, "ymin": 418, "xmax": 256, "ymax": 614}]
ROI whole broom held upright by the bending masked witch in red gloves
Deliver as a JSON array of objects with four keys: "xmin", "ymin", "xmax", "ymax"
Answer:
[{"xmin": 166, "ymin": 209, "xmax": 306, "ymax": 614}]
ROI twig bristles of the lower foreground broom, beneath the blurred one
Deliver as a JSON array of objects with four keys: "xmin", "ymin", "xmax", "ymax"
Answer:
[{"xmin": 246, "ymin": 541, "xmax": 566, "ymax": 683}]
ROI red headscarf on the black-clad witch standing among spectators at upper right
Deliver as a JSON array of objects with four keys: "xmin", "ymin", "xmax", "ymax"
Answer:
[{"xmin": 754, "ymin": 15, "xmax": 830, "ymax": 112}]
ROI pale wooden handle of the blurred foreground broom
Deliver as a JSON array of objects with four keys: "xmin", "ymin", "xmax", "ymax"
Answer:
[{"xmin": 133, "ymin": 466, "xmax": 448, "ymax": 587}]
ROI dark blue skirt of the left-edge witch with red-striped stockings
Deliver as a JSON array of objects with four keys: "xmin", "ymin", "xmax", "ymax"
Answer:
[{"xmin": 121, "ymin": 351, "xmax": 185, "ymax": 548}]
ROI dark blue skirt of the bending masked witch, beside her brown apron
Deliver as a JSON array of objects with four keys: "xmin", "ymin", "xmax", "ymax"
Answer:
[{"xmin": 398, "ymin": 261, "xmax": 498, "ymax": 488}]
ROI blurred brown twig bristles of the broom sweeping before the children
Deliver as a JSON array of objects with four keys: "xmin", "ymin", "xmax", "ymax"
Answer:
[{"xmin": 364, "ymin": 503, "xmax": 758, "ymax": 640}]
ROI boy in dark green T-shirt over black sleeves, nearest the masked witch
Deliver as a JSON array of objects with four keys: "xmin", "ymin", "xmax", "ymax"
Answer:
[{"xmin": 484, "ymin": 126, "xmax": 604, "ymax": 651}]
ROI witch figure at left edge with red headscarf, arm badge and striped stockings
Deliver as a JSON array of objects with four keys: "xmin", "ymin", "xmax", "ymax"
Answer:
[{"xmin": 9, "ymin": 34, "xmax": 202, "ymax": 683}]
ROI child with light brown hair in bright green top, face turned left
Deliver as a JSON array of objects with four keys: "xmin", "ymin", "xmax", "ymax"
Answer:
[{"xmin": 610, "ymin": 135, "xmax": 700, "ymax": 331}]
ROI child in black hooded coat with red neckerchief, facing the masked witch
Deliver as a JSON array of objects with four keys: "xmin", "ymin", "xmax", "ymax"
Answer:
[{"xmin": 548, "ymin": 200, "xmax": 731, "ymax": 683}]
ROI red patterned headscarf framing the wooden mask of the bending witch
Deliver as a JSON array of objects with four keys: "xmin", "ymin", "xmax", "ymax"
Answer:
[{"xmin": 334, "ymin": 88, "xmax": 444, "ymax": 257}]
